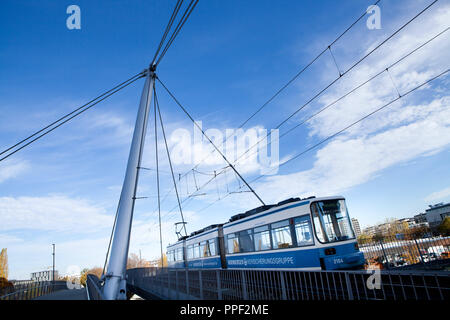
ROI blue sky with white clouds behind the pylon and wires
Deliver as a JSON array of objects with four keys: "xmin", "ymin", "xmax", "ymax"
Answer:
[{"xmin": 0, "ymin": 0, "xmax": 450, "ymax": 278}]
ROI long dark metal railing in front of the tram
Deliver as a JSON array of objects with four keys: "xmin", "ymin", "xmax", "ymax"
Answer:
[{"xmin": 127, "ymin": 268, "xmax": 450, "ymax": 300}]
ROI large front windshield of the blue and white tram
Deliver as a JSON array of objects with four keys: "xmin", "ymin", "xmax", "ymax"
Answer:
[{"xmin": 311, "ymin": 199, "xmax": 355, "ymax": 243}]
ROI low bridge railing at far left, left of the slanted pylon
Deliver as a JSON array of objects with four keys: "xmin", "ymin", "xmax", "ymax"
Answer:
[{"xmin": 0, "ymin": 280, "xmax": 67, "ymax": 300}]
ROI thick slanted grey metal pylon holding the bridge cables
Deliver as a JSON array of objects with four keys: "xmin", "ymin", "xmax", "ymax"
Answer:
[{"xmin": 103, "ymin": 70, "xmax": 155, "ymax": 300}]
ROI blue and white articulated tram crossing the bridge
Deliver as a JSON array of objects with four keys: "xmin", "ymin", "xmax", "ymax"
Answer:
[{"xmin": 168, "ymin": 197, "xmax": 364, "ymax": 270}]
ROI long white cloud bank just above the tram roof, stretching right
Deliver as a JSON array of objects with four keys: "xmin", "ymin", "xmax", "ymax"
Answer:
[{"xmin": 258, "ymin": 97, "xmax": 450, "ymax": 201}]
